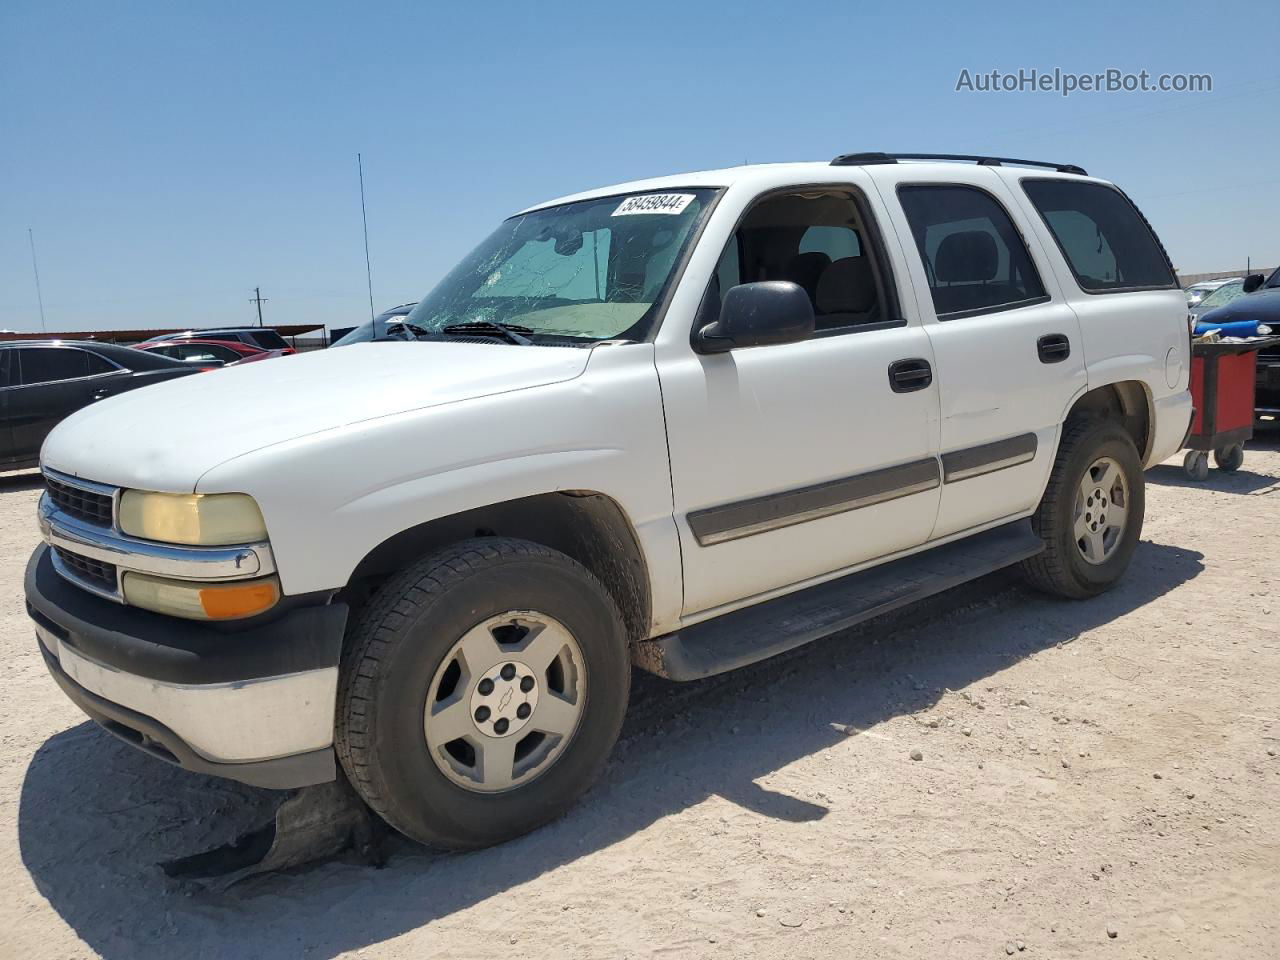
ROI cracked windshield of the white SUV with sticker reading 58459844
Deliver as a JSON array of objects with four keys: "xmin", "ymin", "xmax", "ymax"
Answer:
[{"xmin": 389, "ymin": 189, "xmax": 714, "ymax": 344}]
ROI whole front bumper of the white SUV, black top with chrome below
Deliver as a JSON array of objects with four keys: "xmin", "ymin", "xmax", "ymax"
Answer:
[{"xmin": 26, "ymin": 547, "xmax": 347, "ymax": 787}]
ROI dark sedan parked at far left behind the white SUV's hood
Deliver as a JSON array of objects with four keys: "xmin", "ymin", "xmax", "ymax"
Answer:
[{"xmin": 0, "ymin": 340, "xmax": 209, "ymax": 470}]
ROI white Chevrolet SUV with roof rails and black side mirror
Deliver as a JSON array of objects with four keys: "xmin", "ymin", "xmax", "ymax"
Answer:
[{"xmin": 27, "ymin": 154, "xmax": 1192, "ymax": 847}]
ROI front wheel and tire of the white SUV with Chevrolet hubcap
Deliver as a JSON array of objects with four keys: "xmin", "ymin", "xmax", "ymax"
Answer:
[{"xmin": 335, "ymin": 538, "xmax": 631, "ymax": 850}]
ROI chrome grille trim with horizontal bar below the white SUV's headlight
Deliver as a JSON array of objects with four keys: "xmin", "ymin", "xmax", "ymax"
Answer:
[{"xmin": 38, "ymin": 470, "xmax": 275, "ymax": 603}]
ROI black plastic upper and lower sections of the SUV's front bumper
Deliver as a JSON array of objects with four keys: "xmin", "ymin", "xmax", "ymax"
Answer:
[{"xmin": 26, "ymin": 545, "xmax": 348, "ymax": 788}]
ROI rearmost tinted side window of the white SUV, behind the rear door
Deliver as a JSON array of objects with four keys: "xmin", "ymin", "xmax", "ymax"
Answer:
[{"xmin": 1023, "ymin": 180, "xmax": 1175, "ymax": 293}]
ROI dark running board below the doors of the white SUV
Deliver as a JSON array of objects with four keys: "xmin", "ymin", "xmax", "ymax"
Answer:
[{"xmin": 632, "ymin": 520, "xmax": 1044, "ymax": 680}]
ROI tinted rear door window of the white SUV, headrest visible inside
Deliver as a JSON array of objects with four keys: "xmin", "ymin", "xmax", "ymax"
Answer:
[{"xmin": 897, "ymin": 184, "xmax": 1047, "ymax": 320}]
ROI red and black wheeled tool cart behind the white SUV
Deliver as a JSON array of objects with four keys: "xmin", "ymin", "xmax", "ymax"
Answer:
[{"xmin": 1183, "ymin": 337, "xmax": 1280, "ymax": 480}]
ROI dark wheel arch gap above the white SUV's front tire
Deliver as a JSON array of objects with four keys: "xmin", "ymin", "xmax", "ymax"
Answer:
[{"xmin": 340, "ymin": 490, "xmax": 653, "ymax": 643}]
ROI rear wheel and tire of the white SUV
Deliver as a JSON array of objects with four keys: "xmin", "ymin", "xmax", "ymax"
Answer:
[{"xmin": 1021, "ymin": 420, "xmax": 1146, "ymax": 599}]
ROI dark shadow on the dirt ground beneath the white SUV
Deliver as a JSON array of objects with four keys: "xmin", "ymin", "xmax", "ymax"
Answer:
[{"xmin": 18, "ymin": 541, "xmax": 1203, "ymax": 960}]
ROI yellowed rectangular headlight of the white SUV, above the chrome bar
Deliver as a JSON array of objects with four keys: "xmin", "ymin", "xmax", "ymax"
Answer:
[{"xmin": 120, "ymin": 490, "xmax": 266, "ymax": 547}]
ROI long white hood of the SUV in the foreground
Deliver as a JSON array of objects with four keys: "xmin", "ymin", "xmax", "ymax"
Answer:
[{"xmin": 41, "ymin": 342, "xmax": 591, "ymax": 493}]
